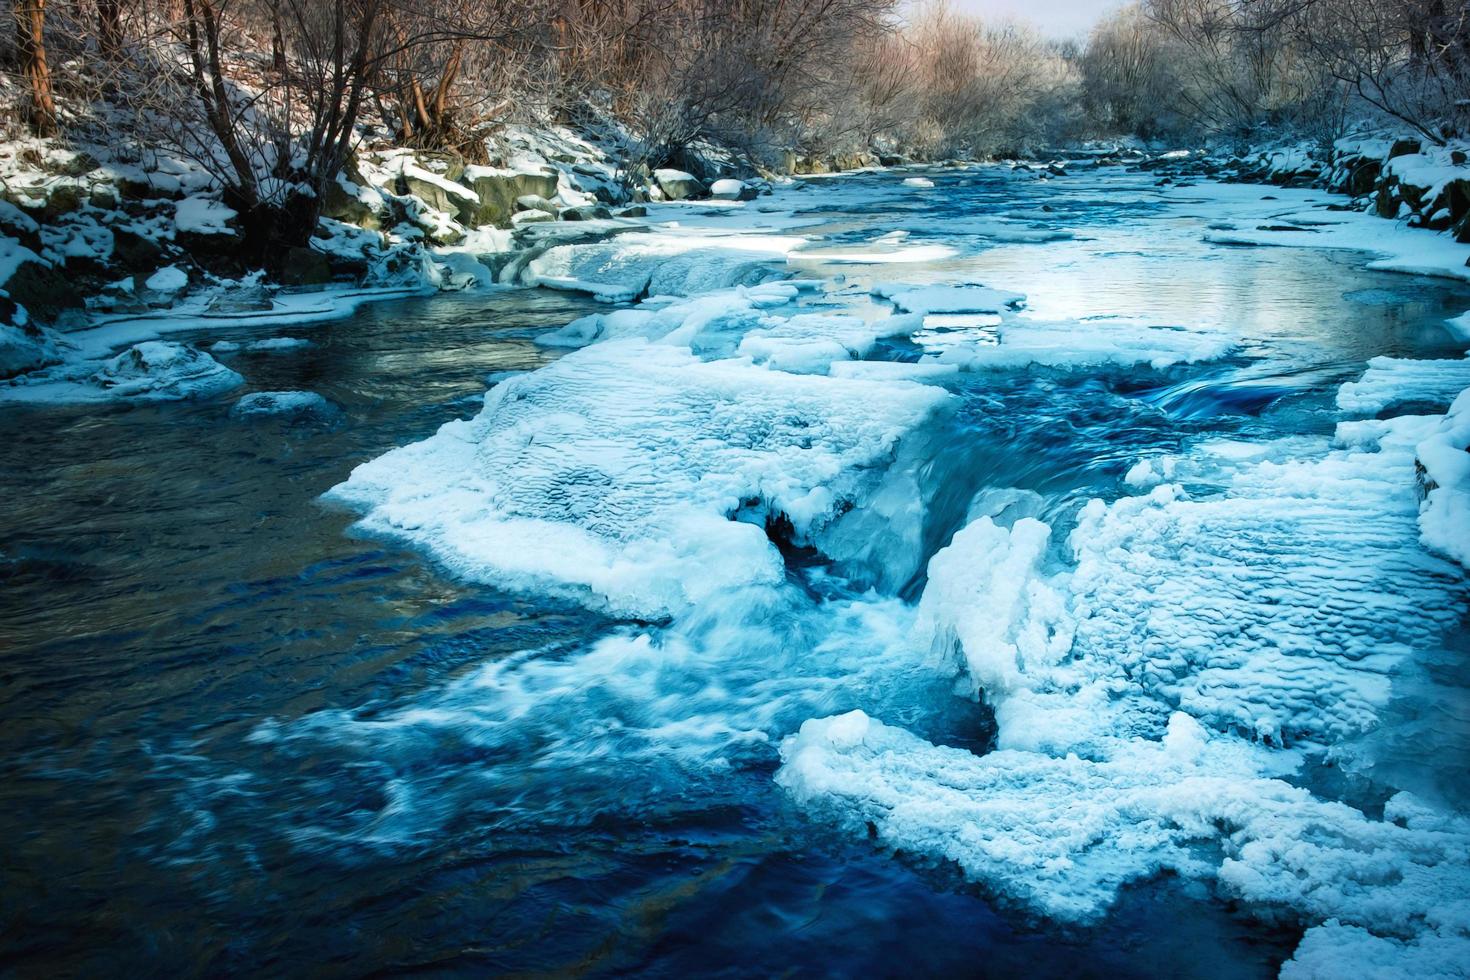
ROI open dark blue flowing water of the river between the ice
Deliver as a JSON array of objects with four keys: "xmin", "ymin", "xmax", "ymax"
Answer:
[{"xmin": 0, "ymin": 164, "xmax": 1470, "ymax": 977}]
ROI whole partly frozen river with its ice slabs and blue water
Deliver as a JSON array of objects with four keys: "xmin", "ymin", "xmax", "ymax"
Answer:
[{"xmin": 0, "ymin": 167, "xmax": 1470, "ymax": 977}]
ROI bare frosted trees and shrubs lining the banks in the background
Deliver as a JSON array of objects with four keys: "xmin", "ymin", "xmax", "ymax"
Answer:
[{"xmin": 4, "ymin": 0, "xmax": 1470, "ymax": 259}]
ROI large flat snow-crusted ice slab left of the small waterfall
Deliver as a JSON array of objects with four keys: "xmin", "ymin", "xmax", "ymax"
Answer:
[{"xmin": 329, "ymin": 341, "xmax": 950, "ymax": 619}]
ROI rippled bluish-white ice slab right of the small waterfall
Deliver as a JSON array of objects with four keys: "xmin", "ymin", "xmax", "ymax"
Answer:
[{"xmin": 1061, "ymin": 436, "xmax": 1463, "ymax": 742}]
